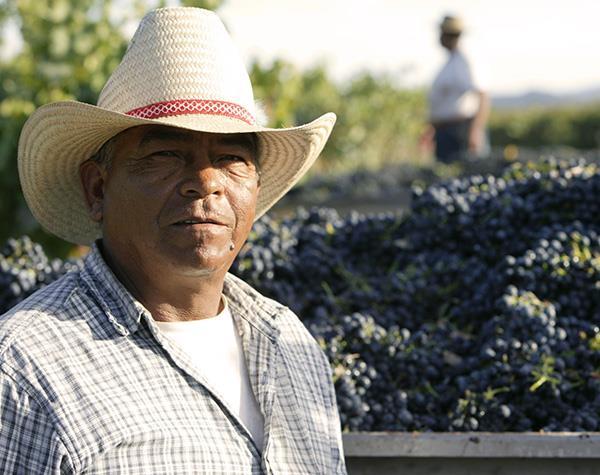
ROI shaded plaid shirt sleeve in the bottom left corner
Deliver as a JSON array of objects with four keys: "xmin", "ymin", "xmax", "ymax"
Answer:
[{"xmin": 0, "ymin": 369, "xmax": 74, "ymax": 474}]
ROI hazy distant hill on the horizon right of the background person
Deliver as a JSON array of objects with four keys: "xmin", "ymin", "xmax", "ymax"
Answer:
[{"xmin": 492, "ymin": 87, "xmax": 600, "ymax": 109}]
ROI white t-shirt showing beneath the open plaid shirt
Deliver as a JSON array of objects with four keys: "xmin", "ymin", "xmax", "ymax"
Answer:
[{"xmin": 156, "ymin": 297, "xmax": 264, "ymax": 448}]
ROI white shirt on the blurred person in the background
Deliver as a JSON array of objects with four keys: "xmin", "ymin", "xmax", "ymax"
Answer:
[{"xmin": 429, "ymin": 49, "xmax": 480, "ymax": 122}]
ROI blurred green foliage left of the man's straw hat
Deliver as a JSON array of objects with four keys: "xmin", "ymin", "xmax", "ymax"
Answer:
[{"xmin": 0, "ymin": 0, "xmax": 131, "ymax": 256}]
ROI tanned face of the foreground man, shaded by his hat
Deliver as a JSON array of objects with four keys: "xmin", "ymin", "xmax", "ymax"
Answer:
[{"xmin": 82, "ymin": 126, "xmax": 259, "ymax": 278}]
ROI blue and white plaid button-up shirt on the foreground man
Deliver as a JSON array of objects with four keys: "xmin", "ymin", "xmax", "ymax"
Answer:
[{"xmin": 0, "ymin": 247, "xmax": 345, "ymax": 475}]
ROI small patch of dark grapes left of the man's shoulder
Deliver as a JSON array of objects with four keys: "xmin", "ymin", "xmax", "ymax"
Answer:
[{"xmin": 0, "ymin": 236, "xmax": 78, "ymax": 315}]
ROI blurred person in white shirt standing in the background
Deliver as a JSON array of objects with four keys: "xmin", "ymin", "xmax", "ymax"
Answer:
[{"xmin": 429, "ymin": 16, "xmax": 489, "ymax": 163}]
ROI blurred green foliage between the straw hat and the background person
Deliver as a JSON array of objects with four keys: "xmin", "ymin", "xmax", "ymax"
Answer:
[{"xmin": 251, "ymin": 60, "xmax": 426, "ymax": 173}]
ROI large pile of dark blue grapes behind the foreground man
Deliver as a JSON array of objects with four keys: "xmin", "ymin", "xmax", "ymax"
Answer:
[{"xmin": 0, "ymin": 159, "xmax": 600, "ymax": 431}]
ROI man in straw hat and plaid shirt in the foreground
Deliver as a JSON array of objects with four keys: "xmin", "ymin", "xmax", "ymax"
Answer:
[{"xmin": 0, "ymin": 8, "xmax": 345, "ymax": 474}]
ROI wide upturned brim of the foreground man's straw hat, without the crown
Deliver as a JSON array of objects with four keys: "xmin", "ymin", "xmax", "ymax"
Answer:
[{"xmin": 18, "ymin": 101, "xmax": 336, "ymax": 245}]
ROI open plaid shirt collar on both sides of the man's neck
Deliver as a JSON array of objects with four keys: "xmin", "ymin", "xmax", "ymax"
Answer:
[{"xmin": 81, "ymin": 242, "xmax": 282, "ymax": 341}]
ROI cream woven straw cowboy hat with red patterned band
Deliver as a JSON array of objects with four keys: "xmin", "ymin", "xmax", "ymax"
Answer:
[{"xmin": 18, "ymin": 7, "xmax": 336, "ymax": 244}]
